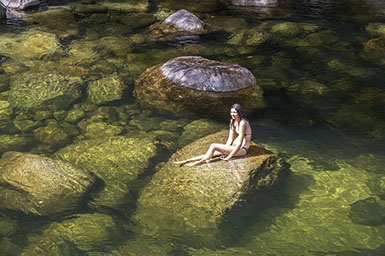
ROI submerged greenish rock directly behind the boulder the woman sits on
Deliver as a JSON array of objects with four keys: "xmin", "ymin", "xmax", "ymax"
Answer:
[{"xmin": 179, "ymin": 118, "xmax": 226, "ymax": 148}]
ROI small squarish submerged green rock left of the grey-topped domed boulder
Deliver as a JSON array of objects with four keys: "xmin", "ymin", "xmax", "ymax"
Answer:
[{"xmin": 87, "ymin": 74, "xmax": 127, "ymax": 104}]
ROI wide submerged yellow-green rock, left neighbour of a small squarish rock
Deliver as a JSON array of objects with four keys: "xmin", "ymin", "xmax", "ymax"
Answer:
[{"xmin": 9, "ymin": 73, "xmax": 82, "ymax": 111}]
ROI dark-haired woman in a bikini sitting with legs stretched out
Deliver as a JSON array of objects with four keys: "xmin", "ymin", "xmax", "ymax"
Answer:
[{"xmin": 174, "ymin": 104, "xmax": 251, "ymax": 166}]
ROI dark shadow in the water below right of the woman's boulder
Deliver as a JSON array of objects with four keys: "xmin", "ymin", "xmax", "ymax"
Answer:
[{"xmin": 220, "ymin": 171, "xmax": 315, "ymax": 247}]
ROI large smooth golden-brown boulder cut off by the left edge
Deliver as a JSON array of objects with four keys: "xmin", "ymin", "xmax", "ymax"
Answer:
[{"xmin": 0, "ymin": 152, "xmax": 95, "ymax": 215}]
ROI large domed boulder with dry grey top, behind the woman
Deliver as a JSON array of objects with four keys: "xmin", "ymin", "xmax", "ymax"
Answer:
[{"xmin": 135, "ymin": 56, "xmax": 265, "ymax": 116}]
